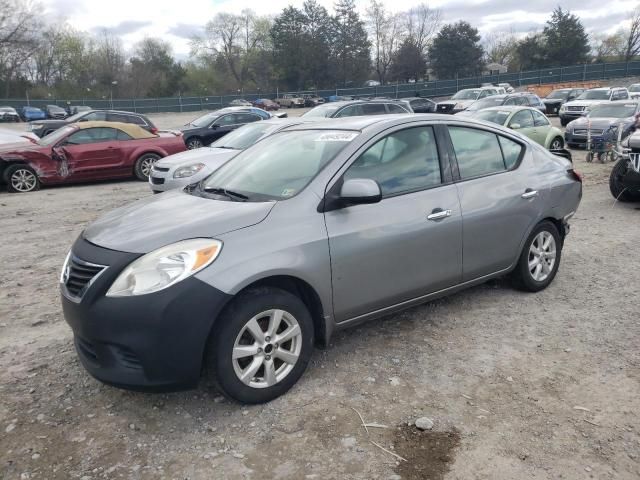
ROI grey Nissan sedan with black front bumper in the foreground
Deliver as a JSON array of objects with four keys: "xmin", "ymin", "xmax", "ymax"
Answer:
[{"xmin": 60, "ymin": 114, "xmax": 582, "ymax": 403}]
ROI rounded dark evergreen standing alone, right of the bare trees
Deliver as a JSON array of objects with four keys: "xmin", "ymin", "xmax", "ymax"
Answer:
[{"xmin": 429, "ymin": 21, "xmax": 484, "ymax": 78}]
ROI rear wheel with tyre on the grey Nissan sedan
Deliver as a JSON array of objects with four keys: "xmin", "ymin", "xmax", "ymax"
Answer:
[{"xmin": 512, "ymin": 220, "xmax": 562, "ymax": 292}]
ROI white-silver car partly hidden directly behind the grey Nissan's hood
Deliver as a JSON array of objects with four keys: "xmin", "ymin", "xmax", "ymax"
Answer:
[{"xmin": 149, "ymin": 118, "xmax": 320, "ymax": 193}]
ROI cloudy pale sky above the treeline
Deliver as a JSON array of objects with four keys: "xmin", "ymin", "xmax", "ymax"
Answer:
[{"xmin": 40, "ymin": 0, "xmax": 639, "ymax": 59}]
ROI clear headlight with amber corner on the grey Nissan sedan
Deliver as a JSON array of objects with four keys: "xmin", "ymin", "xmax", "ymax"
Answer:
[{"xmin": 107, "ymin": 238, "xmax": 222, "ymax": 297}]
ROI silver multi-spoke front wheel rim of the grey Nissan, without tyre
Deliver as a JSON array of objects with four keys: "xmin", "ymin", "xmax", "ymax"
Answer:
[{"xmin": 231, "ymin": 309, "xmax": 302, "ymax": 388}]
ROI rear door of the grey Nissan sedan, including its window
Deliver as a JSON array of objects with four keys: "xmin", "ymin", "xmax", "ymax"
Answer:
[{"xmin": 448, "ymin": 125, "xmax": 545, "ymax": 281}]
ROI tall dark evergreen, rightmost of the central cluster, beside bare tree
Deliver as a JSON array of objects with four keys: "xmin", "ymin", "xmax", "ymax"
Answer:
[{"xmin": 332, "ymin": 0, "xmax": 371, "ymax": 85}]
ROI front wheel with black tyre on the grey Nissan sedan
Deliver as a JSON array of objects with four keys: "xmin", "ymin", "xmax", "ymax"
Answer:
[{"xmin": 206, "ymin": 288, "xmax": 313, "ymax": 404}]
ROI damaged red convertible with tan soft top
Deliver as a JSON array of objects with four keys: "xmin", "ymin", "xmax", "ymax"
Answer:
[{"xmin": 0, "ymin": 122, "xmax": 186, "ymax": 192}]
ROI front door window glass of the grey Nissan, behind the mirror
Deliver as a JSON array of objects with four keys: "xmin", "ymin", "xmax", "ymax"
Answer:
[{"xmin": 344, "ymin": 127, "xmax": 442, "ymax": 197}]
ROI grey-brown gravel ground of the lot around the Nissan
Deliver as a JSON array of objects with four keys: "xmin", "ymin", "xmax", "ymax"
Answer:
[{"xmin": 0, "ymin": 111, "xmax": 640, "ymax": 480}]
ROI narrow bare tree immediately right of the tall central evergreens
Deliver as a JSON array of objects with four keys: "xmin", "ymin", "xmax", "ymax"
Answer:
[{"xmin": 365, "ymin": 0, "xmax": 403, "ymax": 84}]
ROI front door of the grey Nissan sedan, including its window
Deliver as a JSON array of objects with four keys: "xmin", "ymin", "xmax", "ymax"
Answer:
[{"xmin": 325, "ymin": 126, "xmax": 462, "ymax": 322}]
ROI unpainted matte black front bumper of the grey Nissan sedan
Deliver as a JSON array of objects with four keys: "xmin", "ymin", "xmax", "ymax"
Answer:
[{"xmin": 61, "ymin": 238, "xmax": 230, "ymax": 391}]
